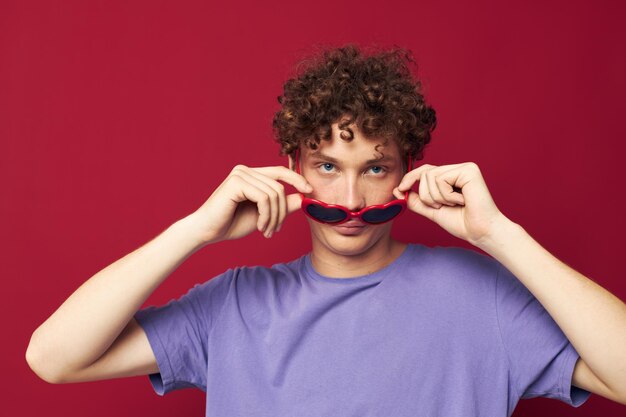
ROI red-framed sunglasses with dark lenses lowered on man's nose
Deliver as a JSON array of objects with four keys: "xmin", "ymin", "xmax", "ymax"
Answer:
[{"xmin": 295, "ymin": 150, "xmax": 412, "ymax": 224}]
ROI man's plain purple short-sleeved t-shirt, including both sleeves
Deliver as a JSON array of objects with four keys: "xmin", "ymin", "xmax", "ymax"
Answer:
[{"xmin": 135, "ymin": 244, "xmax": 590, "ymax": 417}]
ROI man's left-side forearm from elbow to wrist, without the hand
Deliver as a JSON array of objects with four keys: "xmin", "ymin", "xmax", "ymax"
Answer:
[{"xmin": 27, "ymin": 217, "xmax": 202, "ymax": 374}]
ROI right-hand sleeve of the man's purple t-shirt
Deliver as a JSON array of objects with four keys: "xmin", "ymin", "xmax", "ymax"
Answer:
[{"xmin": 496, "ymin": 262, "xmax": 591, "ymax": 407}]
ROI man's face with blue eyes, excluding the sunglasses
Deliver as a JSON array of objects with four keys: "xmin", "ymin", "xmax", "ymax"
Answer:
[{"xmin": 300, "ymin": 123, "xmax": 404, "ymax": 256}]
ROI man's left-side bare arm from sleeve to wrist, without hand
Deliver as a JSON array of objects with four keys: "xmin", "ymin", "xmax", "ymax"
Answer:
[{"xmin": 26, "ymin": 217, "xmax": 201, "ymax": 383}]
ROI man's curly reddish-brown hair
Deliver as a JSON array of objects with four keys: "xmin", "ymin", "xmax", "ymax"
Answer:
[{"xmin": 272, "ymin": 45, "xmax": 437, "ymax": 160}]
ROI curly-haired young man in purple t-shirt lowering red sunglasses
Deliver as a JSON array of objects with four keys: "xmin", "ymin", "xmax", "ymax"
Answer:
[{"xmin": 26, "ymin": 47, "xmax": 626, "ymax": 416}]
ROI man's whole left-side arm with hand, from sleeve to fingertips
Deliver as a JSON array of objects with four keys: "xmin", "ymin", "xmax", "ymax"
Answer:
[{"xmin": 26, "ymin": 166, "xmax": 310, "ymax": 383}]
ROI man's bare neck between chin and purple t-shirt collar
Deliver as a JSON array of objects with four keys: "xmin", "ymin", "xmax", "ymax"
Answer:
[{"xmin": 311, "ymin": 237, "xmax": 407, "ymax": 279}]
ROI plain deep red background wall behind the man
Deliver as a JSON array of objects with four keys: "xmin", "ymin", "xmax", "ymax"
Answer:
[{"xmin": 0, "ymin": 0, "xmax": 626, "ymax": 416}]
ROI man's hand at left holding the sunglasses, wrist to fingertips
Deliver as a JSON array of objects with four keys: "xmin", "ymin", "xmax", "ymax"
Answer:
[{"xmin": 189, "ymin": 165, "xmax": 313, "ymax": 244}]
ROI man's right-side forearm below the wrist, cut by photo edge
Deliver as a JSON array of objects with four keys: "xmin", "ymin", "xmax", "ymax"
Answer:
[{"xmin": 477, "ymin": 218, "xmax": 626, "ymax": 393}]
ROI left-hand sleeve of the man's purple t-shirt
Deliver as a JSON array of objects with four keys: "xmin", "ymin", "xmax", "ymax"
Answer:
[{"xmin": 135, "ymin": 270, "xmax": 231, "ymax": 395}]
